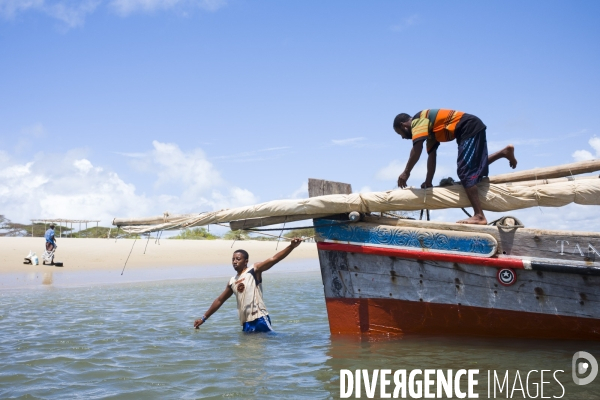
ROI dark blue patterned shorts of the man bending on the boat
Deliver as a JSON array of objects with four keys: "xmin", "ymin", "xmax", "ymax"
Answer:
[{"xmin": 456, "ymin": 129, "xmax": 489, "ymax": 188}]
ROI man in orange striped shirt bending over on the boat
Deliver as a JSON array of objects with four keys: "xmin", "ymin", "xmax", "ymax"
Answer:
[{"xmin": 394, "ymin": 108, "xmax": 517, "ymax": 225}]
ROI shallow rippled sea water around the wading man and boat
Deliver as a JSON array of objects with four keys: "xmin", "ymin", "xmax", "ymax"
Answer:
[{"xmin": 0, "ymin": 265, "xmax": 600, "ymax": 399}]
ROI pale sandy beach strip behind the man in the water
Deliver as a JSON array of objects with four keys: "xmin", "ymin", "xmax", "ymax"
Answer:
[{"xmin": 0, "ymin": 237, "xmax": 318, "ymax": 273}]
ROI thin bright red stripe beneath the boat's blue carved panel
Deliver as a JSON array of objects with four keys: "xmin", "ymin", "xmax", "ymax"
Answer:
[{"xmin": 317, "ymin": 242, "xmax": 524, "ymax": 269}]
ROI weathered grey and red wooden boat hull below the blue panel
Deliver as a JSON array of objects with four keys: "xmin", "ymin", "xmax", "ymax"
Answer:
[{"xmin": 317, "ymin": 221, "xmax": 600, "ymax": 340}]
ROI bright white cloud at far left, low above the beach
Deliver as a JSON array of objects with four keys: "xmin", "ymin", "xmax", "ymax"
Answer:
[{"xmin": 0, "ymin": 152, "xmax": 150, "ymax": 224}]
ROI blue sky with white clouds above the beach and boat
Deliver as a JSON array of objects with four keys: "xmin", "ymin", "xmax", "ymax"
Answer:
[{"xmin": 0, "ymin": 0, "xmax": 600, "ymax": 231}]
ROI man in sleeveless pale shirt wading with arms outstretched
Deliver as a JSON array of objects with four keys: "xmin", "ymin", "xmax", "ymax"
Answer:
[{"xmin": 194, "ymin": 238, "xmax": 302, "ymax": 332}]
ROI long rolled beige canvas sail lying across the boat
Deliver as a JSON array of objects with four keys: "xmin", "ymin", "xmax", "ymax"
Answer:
[{"xmin": 113, "ymin": 179, "xmax": 600, "ymax": 233}]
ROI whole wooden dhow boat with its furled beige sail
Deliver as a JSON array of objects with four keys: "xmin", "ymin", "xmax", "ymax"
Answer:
[{"xmin": 113, "ymin": 160, "xmax": 600, "ymax": 340}]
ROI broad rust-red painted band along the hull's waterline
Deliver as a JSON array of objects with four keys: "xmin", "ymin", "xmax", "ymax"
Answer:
[{"xmin": 325, "ymin": 297, "xmax": 600, "ymax": 340}]
